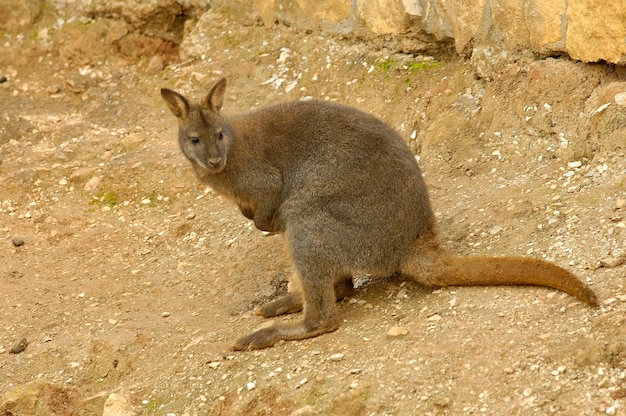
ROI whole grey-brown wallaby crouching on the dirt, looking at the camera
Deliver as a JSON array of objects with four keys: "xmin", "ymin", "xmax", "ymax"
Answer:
[{"xmin": 161, "ymin": 78, "xmax": 598, "ymax": 350}]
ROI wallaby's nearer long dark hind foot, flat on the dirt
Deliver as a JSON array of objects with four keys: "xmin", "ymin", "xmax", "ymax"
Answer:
[{"xmin": 233, "ymin": 320, "xmax": 339, "ymax": 351}]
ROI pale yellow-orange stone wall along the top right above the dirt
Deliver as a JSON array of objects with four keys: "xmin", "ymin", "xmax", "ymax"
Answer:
[{"xmin": 246, "ymin": 0, "xmax": 626, "ymax": 65}]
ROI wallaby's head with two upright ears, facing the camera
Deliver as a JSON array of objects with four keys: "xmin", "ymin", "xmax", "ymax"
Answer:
[{"xmin": 161, "ymin": 78, "xmax": 232, "ymax": 173}]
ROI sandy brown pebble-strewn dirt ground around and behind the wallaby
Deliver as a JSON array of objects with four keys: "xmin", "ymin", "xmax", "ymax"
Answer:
[{"xmin": 0, "ymin": 4, "xmax": 626, "ymax": 416}]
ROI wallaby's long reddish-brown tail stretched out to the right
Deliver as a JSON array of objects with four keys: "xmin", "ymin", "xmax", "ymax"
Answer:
[{"xmin": 436, "ymin": 256, "xmax": 598, "ymax": 306}]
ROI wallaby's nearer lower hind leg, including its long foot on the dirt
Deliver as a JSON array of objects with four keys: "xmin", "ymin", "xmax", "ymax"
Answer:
[{"xmin": 233, "ymin": 258, "xmax": 339, "ymax": 350}]
